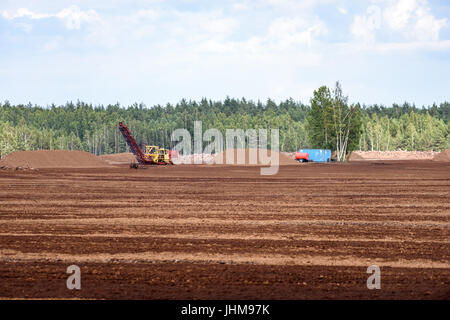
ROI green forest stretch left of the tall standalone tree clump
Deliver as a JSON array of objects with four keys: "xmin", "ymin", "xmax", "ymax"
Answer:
[{"xmin": 0, "ymin": 98, "xmax": 309, "ymax": 155}]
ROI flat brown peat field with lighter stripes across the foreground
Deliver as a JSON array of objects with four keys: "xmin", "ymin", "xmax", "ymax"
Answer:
[{"xmin": 0, "ymin": 161, "xmax": 450, "ymax": 299}]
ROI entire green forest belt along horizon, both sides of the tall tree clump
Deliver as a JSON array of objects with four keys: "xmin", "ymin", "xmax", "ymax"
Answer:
[{"xmin": 0, "ymin": 93, "xmax": 450, "ymax": 156}]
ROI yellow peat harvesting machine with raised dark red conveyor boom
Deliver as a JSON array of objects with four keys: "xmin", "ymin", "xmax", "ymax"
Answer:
[{"xmin": 119, "ymin": 122, "xmax": 177, "ymax": 169}]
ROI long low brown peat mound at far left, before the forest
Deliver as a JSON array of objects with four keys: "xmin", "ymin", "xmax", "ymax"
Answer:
[{"xmin": 0, "ymin": 150, "xmax": 109, "ymax": 168}]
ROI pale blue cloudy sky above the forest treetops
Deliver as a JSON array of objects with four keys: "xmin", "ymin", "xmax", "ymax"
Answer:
[{"xmin": 0, "ymin": 0, "xmax": 450, "ymax": 106}]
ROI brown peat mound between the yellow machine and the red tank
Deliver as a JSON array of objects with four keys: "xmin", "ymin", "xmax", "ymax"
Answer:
[{"xmin": 214, "ymin": 149, "xmax": 297, "ymax": 165}]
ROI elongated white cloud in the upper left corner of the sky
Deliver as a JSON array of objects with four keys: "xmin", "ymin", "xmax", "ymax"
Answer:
[{"xmin": 2, "ymin": 6, "xmax": 100, "ymax": 30}]
